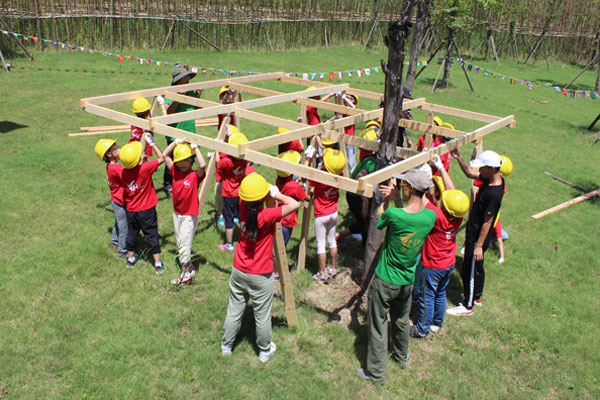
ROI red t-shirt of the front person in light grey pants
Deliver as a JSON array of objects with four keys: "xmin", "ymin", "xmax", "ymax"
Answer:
[{"xmin": 233, "ymin": 200, "xmax": 282, "ymax": 275}]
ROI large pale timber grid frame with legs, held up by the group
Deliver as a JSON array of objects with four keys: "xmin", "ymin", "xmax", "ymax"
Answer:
[{"xmin": 80, "ymin": 72, "xmax": 516, "ymax": 326}]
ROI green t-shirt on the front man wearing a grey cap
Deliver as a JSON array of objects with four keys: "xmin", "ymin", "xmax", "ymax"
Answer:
[{"xmin": 375, "ymin": 208, "xmax": 435, "ymax": 285}]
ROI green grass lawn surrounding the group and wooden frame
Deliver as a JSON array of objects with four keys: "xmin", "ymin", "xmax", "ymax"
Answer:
[{"xmin": 0, "ymin": 47, "xmax": 600, "ymax": 399}]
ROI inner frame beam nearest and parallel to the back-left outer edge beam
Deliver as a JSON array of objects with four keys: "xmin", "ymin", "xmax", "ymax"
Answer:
[{"xmin": 152, "ymin": 84, "xmax": 348, "ymax": 125}]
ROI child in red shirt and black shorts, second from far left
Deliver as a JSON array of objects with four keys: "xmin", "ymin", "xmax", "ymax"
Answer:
[{"xmin": 119, "ymin": 133, "xmax": 165, "ymax": 275}]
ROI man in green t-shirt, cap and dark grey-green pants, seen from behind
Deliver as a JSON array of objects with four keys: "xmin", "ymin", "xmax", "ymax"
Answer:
[{"xmin": 356, "ymin": 169, "xmax": 435, "ymax": 384}]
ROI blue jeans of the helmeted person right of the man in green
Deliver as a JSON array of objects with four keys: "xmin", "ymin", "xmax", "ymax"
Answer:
[{"xmin": 416, "ymin": 265, "xmax": 454, "ymax": 336}]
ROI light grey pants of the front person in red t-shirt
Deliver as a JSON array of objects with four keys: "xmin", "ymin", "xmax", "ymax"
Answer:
[{"xmin": 222, "ymin": 267, "xmax": 273, "ymax": 351}]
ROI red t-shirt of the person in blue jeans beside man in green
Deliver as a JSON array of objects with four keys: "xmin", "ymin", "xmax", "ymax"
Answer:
[{"xmin": 421, "ymin": 203, "xmax": 463, "ymax": 269}]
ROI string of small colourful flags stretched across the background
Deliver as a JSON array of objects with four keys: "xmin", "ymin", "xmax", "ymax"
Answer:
[{"xmin": 0, "ymin": 29, "xmax": 600, "ymax": 100}]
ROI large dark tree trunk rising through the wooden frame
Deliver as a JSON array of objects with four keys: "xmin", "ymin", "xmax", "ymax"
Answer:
[{"xmin": 361, "ymin": 0, "xmax": 415, "ymax": 290}]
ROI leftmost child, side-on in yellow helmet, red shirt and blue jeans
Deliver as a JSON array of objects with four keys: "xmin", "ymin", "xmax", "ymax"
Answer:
[{"xmin": 94, "ymin": 139, "xmax": 127, "ymax": 257}]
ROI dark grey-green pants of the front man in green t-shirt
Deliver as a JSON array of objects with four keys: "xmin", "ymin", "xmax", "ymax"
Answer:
[{"xmin": 367, "ymin": 276, "xmax": 412, "ymax": 383}]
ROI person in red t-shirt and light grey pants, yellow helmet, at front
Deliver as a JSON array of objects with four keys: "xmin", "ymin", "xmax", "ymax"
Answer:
[{"xmin": 221, "ymin": 172, "xmax": 300, "ymax": 363}]
